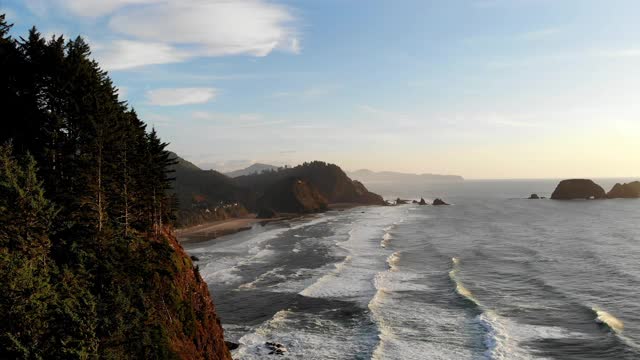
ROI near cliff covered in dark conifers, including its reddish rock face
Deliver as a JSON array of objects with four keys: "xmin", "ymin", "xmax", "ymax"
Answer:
[{"xmin": 0, "ymin": 15, "xmax": 230, "ymax": 359}]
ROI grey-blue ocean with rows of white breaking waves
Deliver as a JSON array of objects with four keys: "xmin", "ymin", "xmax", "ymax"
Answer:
[{"xmin": 185, "ymin": 179, "xmax": 640, "ymax": 360}]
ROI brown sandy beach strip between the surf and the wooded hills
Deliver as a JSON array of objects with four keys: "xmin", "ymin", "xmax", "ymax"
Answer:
[{"xmin": 175, "ymin": 203, "xmax": 372, "ymax": 244}]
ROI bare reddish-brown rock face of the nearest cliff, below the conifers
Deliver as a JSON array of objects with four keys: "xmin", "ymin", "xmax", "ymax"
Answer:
[{"xmin": 160, "ymin": 232, "xmax": 231, "ymax": 360}]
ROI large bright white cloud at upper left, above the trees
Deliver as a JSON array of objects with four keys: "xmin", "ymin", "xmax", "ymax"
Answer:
[{"xmin": 26, "ymin": 0, "xmax": 301, "ymax": 71}]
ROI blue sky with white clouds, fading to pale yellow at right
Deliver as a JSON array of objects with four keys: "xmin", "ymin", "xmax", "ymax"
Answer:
[{"xmin": 0, "ymin": 0, "xmax": 640, "ymax": 179}]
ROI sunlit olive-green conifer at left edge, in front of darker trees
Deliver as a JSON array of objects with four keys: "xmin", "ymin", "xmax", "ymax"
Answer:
[{"xmin": 0, "ymin": 146, "xmax": 55, "ymax": 358}]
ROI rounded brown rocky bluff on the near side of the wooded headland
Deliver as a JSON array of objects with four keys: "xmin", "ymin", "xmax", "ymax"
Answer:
[{"xmin": 258, "ymin": 177, "xmax": 328, "ymax": 214}]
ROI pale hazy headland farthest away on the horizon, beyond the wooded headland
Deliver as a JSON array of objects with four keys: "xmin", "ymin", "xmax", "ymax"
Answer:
[{"xmin": 347, "ymin": 169, "xmax": 464, "ymax": 185}]
